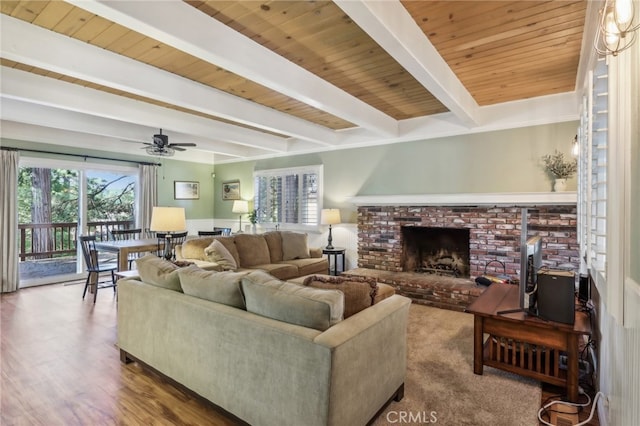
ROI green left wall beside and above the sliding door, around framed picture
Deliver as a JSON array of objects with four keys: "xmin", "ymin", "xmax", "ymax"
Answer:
[{"xmin": 0, "ymin": 139, "xmax": 214, "ymax": 219}]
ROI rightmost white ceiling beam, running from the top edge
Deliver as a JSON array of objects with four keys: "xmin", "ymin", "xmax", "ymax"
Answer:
[{"xmin": 334, "ymin": 0, "xmax": 479, "ymax": 127}]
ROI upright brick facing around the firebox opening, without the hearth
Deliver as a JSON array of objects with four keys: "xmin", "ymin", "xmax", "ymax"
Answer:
[{"xmin": 358, "ymin": 206, "xmax": 579, "ymax": 279}]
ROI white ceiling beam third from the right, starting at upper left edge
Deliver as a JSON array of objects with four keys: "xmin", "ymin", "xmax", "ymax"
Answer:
[{"xmin": 0, "ymin": 14, "xmax": 335, "ymax": 145}]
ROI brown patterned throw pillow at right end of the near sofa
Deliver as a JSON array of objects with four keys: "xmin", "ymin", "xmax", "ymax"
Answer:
[{"xmin": 302, "ymin": 275, "xmax": 378, "ymax": 318}]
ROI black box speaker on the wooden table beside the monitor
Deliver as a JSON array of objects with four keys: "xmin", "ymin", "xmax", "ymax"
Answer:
[{"xmin": 538, "ymin": 270, "xmax": 576, "ymax": 324}]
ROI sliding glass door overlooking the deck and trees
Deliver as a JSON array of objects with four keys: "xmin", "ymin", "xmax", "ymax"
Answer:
[{"xmin": 17, "ymin": 158, "xmax": 137, "ymax": 287}]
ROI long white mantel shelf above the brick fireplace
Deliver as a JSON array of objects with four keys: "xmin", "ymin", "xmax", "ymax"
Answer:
[{"xmin": 350, "ymin": 192, "xmax": 578, "ymax": 206}]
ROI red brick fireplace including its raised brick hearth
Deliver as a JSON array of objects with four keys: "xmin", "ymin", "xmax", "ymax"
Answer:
[{"xmin": 354, "ymin": 203, "xmax": 579, "ymax": 309}]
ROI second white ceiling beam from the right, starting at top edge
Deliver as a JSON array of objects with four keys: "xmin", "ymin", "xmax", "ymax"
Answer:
[{"xmin": 69, "ymin": 0, "xmax": 398, "ymax": 134}]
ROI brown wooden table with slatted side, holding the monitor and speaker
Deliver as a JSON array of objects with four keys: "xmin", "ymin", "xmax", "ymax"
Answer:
[{"xmin": 467, "ymin": 283, "xmax": 591, "ymax": 402}]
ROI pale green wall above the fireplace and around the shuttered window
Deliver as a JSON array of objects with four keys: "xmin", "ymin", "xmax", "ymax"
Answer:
[{"xmin": 215, "ymin": 122, "xmax": 578, "ymax": 222}]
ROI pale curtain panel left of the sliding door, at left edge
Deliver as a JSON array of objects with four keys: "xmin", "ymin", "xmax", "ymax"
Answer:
[{"xmin": 0, "ymin": 149, "xmax": 20, "ymax": 293}]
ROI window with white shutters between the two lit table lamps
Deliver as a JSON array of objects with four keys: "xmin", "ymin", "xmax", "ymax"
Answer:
[{"xmin": 254, "ymin": 166, "xmax": 322, "ymax": 226}]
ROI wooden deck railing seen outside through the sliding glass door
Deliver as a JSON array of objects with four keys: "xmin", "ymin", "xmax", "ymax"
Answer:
[{"xmin": 18, "ymin": 220, "xmax": 133, "ymax": 262}]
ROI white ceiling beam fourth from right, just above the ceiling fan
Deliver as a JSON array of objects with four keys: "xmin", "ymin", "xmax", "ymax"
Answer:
[{"xmin": 0, "ymin": 67, "xmax": 288, "ymax": 152}]
